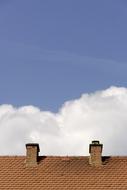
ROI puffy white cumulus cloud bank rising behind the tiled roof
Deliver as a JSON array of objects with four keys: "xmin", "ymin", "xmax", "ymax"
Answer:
[{"xmin": 0, "ymin": 87, "xmax": 127, "ymax": 155}]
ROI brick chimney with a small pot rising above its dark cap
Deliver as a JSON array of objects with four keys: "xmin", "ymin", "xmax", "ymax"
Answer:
[{"xmin": 89, "ymin": 141, "xmax": 103, "ymax": 166}]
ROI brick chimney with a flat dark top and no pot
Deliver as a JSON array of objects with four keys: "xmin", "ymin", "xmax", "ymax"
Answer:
[{"xmin": 26, "ymin": 143, "xmax": 40, "ymax": 166}]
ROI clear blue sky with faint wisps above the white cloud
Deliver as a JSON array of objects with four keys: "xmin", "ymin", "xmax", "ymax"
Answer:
[{"xmin": 0, "ymin": 0, "xmax": 127, "ymax": 111}]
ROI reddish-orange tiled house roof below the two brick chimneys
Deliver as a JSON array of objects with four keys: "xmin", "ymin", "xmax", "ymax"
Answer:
[{"xmin": 0, "ymin": 156, "xmax": 127, "ymax": 190}]
